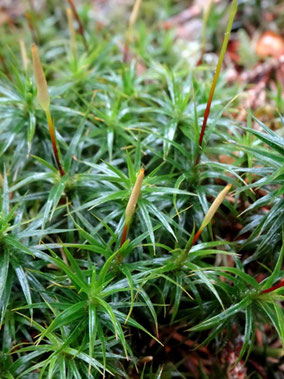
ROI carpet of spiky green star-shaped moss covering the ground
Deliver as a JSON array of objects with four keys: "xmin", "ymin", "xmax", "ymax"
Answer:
[{"xmin": 0, "ymin": 0, "xmax": 284, "ymax": 379}]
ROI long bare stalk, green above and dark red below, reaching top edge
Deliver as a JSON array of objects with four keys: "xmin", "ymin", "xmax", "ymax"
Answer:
[{"xmin": 195, "ymin": 0, "xmax": 238, "ymax": 164}]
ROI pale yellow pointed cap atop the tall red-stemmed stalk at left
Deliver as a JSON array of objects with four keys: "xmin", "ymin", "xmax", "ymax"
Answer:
[{"xmin": 32, "ymin": 43, "xmax": 50, "ymax": 112}]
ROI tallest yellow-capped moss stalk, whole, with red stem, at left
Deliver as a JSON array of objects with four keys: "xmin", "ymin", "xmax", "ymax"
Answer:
[{"xmin": 32, "ymin": 44, "xmax": 64, "ymax": 176}]
